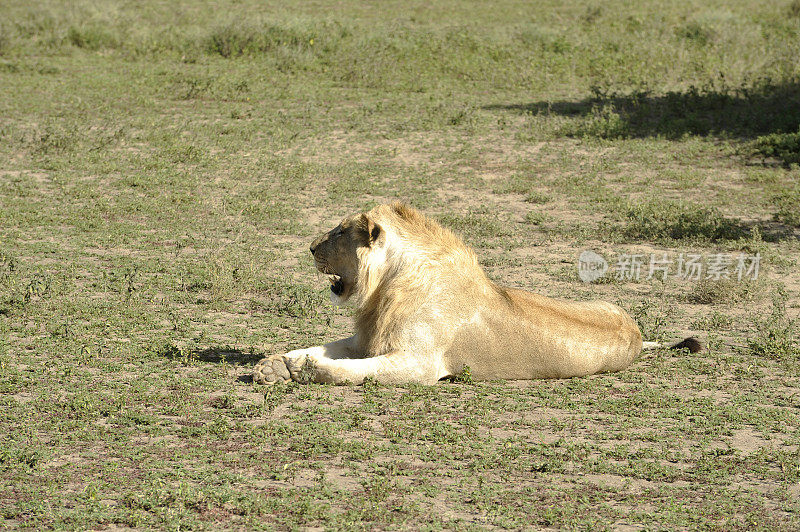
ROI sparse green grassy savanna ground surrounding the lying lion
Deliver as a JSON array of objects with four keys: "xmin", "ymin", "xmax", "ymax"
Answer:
[{"xmin": 0, "ymin": 0, "xmax": 800, "ymax": 530}]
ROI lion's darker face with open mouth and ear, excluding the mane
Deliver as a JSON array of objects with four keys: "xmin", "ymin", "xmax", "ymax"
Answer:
[{"xmin": 311, "ymin": 213, "xmax": 385, "ymax": 305}]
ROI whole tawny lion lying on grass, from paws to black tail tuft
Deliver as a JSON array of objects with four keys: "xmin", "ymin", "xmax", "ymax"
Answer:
[{"xmin": 252, "ymin": 202, "xmax": 700, "ymax": 384}]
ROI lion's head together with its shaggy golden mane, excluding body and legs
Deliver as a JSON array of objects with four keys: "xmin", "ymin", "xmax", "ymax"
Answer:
[{"xmin": 311, "ymin": 202, "xmax": 496, "ymax": 354}]
